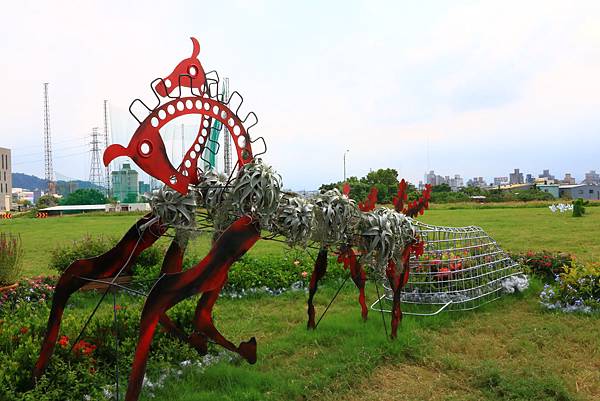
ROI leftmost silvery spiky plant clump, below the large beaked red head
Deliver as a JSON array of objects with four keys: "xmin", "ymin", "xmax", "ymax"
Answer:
[{"xmin": 150, "ymin": 187, "xmax": 196, "ymax": 228}]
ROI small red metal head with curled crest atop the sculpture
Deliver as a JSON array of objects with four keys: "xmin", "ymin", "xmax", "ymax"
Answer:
[{"xmin": 155, "ymin": 37, "xmax": 206, "ymax": 97}]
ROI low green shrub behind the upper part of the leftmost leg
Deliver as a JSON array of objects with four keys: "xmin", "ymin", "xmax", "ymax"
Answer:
[{"xmin": 48, "ymin": 235, "xmax": 164, "ymax": 273}]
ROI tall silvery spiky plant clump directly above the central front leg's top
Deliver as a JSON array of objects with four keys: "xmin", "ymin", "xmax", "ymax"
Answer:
[{"xmin": 231, "ymin": 159, "xmax": 281, "ymax": 223}]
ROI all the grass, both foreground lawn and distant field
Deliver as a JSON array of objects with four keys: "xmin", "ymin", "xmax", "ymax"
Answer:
[{"xmin": 0, "ymin": 208, "xmax": 600, "ymax": 401}]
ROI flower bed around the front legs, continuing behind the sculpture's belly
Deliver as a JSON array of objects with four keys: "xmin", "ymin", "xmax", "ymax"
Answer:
[{"xmin": 0, "ymin": 251, "xmax": 348, "ymax": 401}]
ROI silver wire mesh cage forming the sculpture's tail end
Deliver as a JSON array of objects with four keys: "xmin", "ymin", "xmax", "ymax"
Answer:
[{"xmin": 371, "ymin": 220, "xmax": 522, "ymax": 316}]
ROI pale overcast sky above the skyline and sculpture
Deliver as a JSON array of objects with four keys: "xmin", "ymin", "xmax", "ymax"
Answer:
[{"xmin": 0, "ymin": 0, "xmax": 600, "ymax": 190}]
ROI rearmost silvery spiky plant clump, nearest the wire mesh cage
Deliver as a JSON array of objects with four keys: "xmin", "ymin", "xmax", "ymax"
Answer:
[{"xmin": 359, "ymin": 208, "xmax": 415, "ymax": 271}]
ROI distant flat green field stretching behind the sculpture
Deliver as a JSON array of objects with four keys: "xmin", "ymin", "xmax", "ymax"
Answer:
[{"xmin": 0, "ymin": 207, "xmax": 600, "ymax": 276}]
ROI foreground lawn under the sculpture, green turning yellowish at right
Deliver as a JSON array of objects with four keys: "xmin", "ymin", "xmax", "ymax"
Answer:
[{"xmin": 144, "ymin": 286, "xmax": 600, "ymax": 401}]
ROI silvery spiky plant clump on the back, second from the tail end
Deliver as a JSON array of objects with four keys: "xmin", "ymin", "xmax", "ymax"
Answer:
[{"xmin": 312, "ymin": 188, "xmax": 358, "ymax": 246}]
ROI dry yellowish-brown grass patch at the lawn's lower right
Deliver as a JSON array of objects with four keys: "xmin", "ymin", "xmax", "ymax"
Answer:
[{"xmin": 336, "ymin": 298, "xmax": 600, "ymax": 400}]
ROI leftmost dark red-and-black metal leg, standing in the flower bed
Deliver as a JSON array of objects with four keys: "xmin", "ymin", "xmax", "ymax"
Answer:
[{"xmin": 32, "ymin": 215, "xmax": 164, "ymax": 381}]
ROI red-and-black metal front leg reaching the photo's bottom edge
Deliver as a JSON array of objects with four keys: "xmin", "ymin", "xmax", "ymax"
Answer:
[{"xmin": 125, "ymin": 216, "xmax": 260, "ymax": 401}]
